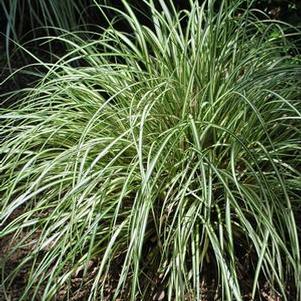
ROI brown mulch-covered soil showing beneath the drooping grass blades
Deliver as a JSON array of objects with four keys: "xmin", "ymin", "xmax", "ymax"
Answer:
[{"xmin": 0, "ymin": 209, "xmax": 288, "ymax": 301}]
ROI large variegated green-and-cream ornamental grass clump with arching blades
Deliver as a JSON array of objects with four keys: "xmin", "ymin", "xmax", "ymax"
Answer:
[{"xmin": 0, "ymin": 0, "xmax": 301, "ymax": 301}]
